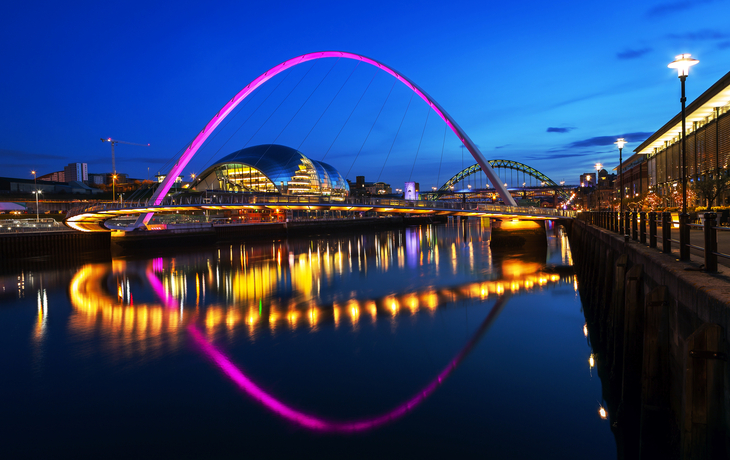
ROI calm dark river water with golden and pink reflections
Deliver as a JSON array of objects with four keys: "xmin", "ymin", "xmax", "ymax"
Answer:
[{"xmin": 0, "ymin": 220, "xmax": 616, "ymax": 459}]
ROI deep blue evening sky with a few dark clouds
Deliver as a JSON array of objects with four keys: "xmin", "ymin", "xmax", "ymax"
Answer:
[{"xmin": 0, "ymin": 0, "xmax": 730, "ymax": 189}]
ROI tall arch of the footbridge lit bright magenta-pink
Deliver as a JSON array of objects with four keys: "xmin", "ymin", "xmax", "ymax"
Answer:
[{"xmin": 135, "ymin": 51, "xmax": 516, "ymax": 227}]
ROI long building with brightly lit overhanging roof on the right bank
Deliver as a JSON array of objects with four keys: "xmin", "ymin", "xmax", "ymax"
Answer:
[{"xmin": 628, "ymin": 72, "xmax": 730, "ymax": 204}]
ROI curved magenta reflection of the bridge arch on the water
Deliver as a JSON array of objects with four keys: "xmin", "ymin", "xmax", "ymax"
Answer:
[{"xmin": 147, "ymin": 271, "xmax": 508, "ymax": 432}]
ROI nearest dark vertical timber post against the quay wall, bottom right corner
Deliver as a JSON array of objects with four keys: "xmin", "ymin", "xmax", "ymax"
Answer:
[{"xmin": 681, "ymin": 323, "xmax": 727, "ymax": 459}]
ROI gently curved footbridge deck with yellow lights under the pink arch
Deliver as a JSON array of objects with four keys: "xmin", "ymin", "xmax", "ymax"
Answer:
[{"xmin": 65, "ymin": 195, "xmax": 576, "ymax": 232}]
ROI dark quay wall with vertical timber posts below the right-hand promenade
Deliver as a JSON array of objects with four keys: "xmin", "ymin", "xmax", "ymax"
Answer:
[{"xmin": 570, "ymin": 220, "xmax": 730, "ymax": 459}]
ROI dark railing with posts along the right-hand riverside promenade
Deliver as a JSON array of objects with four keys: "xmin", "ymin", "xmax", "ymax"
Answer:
[{"xmin": 579, "ymin": 211, "xmax": 730, "ymax": 272}]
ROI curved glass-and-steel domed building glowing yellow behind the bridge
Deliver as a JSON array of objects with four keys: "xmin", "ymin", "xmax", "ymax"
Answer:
[{"xmin": 189, "ymin": 144, "xmax": 350, "ymax": 201}]
